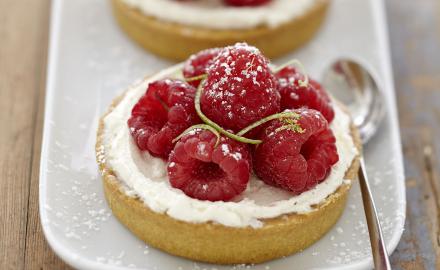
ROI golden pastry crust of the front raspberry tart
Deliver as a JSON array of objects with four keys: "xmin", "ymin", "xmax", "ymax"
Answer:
[{"xmin": 95, "ymin": 81, "xmax": 361, "ymax": 264}]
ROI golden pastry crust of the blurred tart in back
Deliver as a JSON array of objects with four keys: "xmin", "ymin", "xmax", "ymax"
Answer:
[{"xmin": 111, "ymin": 0, "xmax": 330, "ymax": 61}]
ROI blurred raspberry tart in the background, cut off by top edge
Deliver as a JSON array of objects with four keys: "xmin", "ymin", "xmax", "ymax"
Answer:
[{"xmin": 111, "ymin": 0, "xmax": 330, "ymax": 60}]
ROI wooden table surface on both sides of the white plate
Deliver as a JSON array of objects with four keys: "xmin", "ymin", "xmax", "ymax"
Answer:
[{"xmin": 0, "ymin": 0, "xmax": 440, "ymax": 269}]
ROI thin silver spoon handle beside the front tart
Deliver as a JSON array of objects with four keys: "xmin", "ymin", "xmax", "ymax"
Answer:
[{"xmin": 359, "ymin": 157, "xmax": 391, "ymax": 270}]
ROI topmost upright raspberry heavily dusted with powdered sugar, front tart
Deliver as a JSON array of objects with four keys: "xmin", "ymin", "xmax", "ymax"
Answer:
[{"xmin": 201, "ymin": 43, "xmax": 280, "ymax": 132}]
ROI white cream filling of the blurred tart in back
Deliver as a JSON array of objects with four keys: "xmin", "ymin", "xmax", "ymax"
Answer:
[{"xmin": 119, "ymin": 0, "xmax": 324, "ymax": 29}]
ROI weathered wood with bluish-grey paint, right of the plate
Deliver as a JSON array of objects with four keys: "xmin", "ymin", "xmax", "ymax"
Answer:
[{"xmin": 386, "ymin": 0, "xmax": 440, "ymax": 269}]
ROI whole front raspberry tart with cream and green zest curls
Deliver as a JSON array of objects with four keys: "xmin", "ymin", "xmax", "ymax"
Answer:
[{"xmin": 96, "ymin": 43, "xmax": 361, "ymax": 264}]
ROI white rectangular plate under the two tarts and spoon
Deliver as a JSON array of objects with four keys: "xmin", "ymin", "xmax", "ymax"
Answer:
[{"xmin": 40, "ymin": 0, "xmax": 405, "ymax": 270}]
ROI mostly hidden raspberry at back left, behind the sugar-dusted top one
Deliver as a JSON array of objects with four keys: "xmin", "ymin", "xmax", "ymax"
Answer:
[{"xmin": 183, "ymin": 48, "xmax": 221, "ymax": 87}]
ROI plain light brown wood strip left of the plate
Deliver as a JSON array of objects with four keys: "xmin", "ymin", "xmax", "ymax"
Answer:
[{"xmin": 0, "ymin": 0, "xmax": 66, "ymax": 269}]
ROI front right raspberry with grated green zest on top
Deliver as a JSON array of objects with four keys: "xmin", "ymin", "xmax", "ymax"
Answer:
[{"xmin": 253, "ymin": 108, "xmax": 339, "ymax": 194}]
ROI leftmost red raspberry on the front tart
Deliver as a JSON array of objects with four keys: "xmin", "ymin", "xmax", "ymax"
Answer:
[{"xmin": 128, "ymin": 80, "xmax": 200, "ymax": 159}]
